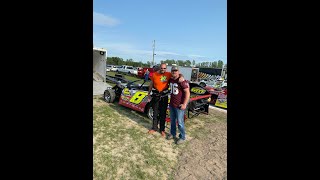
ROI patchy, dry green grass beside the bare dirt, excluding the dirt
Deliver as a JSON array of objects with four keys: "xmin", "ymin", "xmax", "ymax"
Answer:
[{"xmin": 93, "ymin": 98, "xmax": 226, "ymax": 180}]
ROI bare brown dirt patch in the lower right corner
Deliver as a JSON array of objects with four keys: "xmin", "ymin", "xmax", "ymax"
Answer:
[{"xmin": 174, "ymin": 111, "xmax": 227, "ymax": 180}]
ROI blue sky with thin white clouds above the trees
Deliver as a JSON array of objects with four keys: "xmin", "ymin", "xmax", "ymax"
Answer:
[{"xmin": 93, "ymin": 0, "xmax": 227, "ymax": 64}]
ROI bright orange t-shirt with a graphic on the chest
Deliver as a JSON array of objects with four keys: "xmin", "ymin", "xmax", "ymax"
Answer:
[{"xmin": 150, "ymin": 72, "xmax": 172, "ymax": 92}]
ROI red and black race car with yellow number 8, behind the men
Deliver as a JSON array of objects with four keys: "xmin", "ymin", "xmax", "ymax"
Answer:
[{"xmin": 104, "ymin": 80, "xmax": 211, "ymax": 122}]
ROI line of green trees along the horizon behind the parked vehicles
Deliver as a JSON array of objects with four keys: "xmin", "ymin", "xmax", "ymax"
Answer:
[{"xmin": 106, "ymin": 57, "xmax": 226, "ymax": 68}]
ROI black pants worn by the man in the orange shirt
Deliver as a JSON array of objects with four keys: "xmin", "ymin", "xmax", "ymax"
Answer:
[{"xmin": 152, "ymin": 96, "xmax": 168, "ymax": 132}]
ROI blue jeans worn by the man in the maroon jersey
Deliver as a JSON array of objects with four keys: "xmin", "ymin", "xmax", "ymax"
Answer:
[{"xmin": 170, "ymin": 106, "xmax": 186, "ymax": 140}]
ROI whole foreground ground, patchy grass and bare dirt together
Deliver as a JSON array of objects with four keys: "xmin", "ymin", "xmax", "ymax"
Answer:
[{"xmin": 93, "ymin": 97, "xmax": 227, "ymax": 180}]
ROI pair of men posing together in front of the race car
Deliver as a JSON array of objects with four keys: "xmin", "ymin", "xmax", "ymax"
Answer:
[{"xmin": 148, "ymin": 64, "xmax": 190, "ymax": 144}]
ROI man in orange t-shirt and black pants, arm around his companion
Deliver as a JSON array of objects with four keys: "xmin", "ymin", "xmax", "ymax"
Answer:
[{"xmin": 148, "ymin": 63, "xmax": 185, "ymax": 137}]
